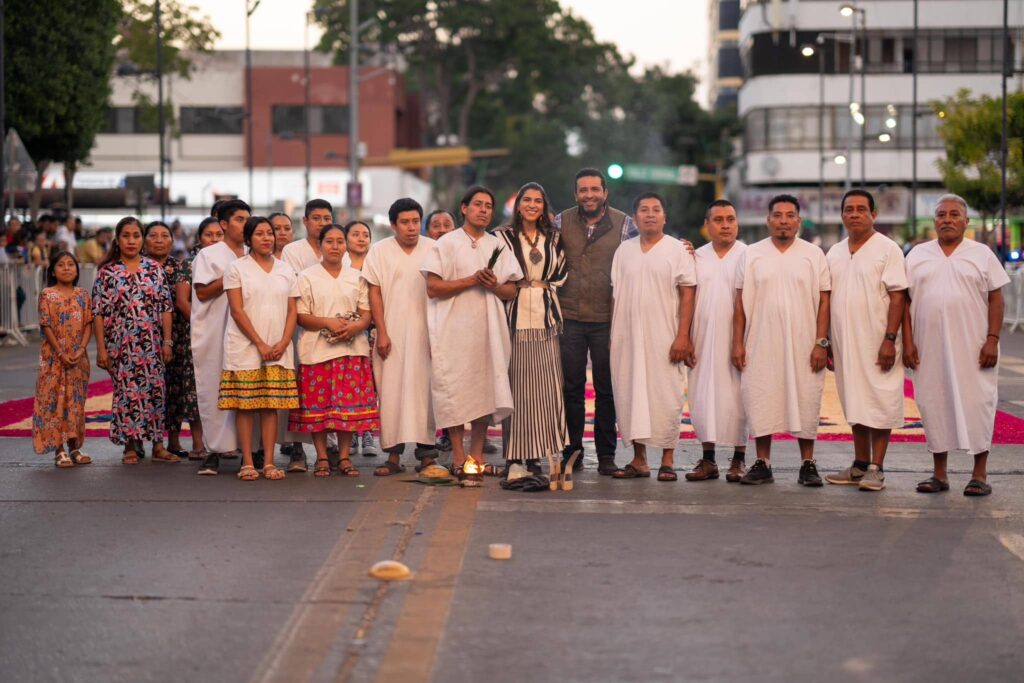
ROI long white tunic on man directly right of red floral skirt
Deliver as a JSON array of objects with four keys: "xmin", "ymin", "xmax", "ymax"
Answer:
[{"xmin": 362, "ymin": 237, "xmax": 435, "ymax": 450}]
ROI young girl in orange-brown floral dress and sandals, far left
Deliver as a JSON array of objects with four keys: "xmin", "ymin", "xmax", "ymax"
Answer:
[{"xmin": 32, "ymin": 252, "xmax": 92, "ymax": 467}]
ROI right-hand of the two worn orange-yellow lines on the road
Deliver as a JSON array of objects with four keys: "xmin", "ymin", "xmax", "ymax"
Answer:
[{"xmin": 377, "ymin": 488, "xmax": 481, "ymax": 683}]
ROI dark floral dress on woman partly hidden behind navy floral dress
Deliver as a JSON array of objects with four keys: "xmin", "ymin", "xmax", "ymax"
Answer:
[{"xmin": 164, "ymin": 256, "xmax": 199, "ymax": 432}]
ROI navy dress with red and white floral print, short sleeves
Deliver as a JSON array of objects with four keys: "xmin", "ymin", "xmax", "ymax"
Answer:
[{"xmin": 92, "ymin": 257, "xmax": 171, "ymax": 445}]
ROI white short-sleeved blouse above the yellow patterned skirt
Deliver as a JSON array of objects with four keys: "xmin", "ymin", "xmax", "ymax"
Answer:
[{"xmin": 224, "ymin": 252, "xmax": 299, "ymax": 371}]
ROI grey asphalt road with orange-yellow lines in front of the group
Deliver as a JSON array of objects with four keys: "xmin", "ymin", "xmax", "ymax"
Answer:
[{"xmin": 0, "ymin": 335, "xmax": 1024, "ymax": 683}]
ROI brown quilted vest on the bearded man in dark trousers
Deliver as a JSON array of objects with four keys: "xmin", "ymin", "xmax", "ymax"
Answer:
[{"xmin": 558, "ymin": 207, "xmax": 626, "ymax": 323}]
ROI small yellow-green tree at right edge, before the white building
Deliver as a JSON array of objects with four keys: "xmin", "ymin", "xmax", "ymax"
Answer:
[{"xmin": 932, "ymin": 90, "xmax": 1024, "ymax": 241}]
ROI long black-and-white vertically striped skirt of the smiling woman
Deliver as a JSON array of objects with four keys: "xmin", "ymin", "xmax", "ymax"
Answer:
[{"xmin": 502, "ymin": 330, "xmax": 568, "ymax": 461}]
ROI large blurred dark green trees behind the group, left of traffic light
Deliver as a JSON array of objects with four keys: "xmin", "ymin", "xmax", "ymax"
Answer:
[{"xmin": 314, "ymin": 0, "xmax": 734, "ymax": 231}]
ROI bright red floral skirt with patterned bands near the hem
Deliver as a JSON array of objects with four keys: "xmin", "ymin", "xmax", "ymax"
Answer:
[{"xmin": 288, "ymin": 355, "xmax": 380, "ymax": 433}]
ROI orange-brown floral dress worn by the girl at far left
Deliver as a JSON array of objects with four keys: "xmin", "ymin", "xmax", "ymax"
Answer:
[{"xmin": 32, "ymin": 287, "xmax": 92, "ymax": 453}]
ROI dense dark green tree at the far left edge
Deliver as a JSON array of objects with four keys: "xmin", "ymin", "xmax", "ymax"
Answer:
[{"xmin": 4, "ymin": 0, "xmax": 121, "ymax": 220}]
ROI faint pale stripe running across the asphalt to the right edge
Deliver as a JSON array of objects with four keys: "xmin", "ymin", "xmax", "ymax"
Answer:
[{"xmin": 478, "ymin": 499, "xmax": 1024, "ymax": 520}]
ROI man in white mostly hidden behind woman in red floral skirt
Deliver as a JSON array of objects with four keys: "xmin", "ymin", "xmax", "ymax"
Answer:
[{"xmin": 278, "ymin": 194, "xmax": 337, "ymax": 472}]
